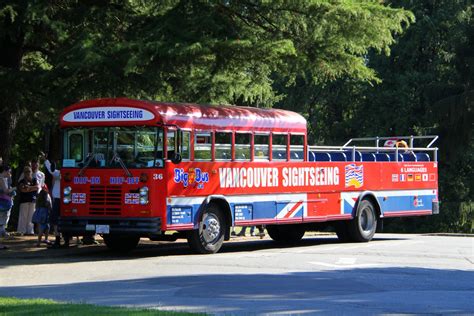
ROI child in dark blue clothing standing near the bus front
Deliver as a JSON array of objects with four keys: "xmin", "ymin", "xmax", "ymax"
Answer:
[{"xmin": 32, "ymin": 184, "xmax": 53, "ymax": 247}]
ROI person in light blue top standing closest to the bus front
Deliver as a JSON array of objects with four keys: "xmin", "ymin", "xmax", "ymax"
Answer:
[{"xmin": 44, "ymin": 159, "xmax": 61, "ymax": 248}]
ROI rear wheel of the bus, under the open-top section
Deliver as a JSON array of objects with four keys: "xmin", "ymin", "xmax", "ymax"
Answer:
[{"xmin": 348, "ymin": 200, "xmax": 377, "ymax": 242}]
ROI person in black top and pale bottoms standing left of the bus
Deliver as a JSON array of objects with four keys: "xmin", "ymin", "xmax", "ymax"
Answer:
[{"xmin": 17, "ymin": 166, "xmax": 40, "ymax": 235}]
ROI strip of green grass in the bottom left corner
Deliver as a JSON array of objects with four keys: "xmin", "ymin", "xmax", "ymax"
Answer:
[{"xmin": 0, "ymin": 297, "xmax": 202, "ymax": 316}]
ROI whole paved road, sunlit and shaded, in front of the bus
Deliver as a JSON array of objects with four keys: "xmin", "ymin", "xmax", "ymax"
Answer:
[{"xmin": 0, "ymin": 234, "xmax": 474, "ymax": 315}]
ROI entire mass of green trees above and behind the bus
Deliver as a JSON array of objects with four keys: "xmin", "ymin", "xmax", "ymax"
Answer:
[{"xmin": 0, "ymin": 0, "xmax": 474, "ymax": 231}]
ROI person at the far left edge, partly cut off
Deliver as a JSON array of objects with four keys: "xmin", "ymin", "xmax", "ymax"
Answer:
[{"xmin": 0, "ymin": 164, "xmax": 15, "ymax": 237}]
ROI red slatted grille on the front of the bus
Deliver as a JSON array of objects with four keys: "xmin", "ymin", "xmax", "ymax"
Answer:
[{"xmin": 89, "ymin": 185, "xmax": 122, "ymax": 215}]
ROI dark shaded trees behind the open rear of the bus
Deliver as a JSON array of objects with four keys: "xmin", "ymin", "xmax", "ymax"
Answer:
[{"xmin": 280, "ymin": 0, "xmax": 474, "ymax": 232}]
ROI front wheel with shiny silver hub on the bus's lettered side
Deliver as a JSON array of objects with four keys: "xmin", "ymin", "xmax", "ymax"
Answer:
[{"xmin": 188, "ymin": 204, "xmax": 227, "ymax": 254}]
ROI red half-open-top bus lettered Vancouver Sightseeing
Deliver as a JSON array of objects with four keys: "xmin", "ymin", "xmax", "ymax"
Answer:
[{"xmin": 59, "ymin": 98, "xmax": 438, "ymax": 253}]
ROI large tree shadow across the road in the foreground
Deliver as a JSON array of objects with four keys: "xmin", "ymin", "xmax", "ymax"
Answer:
[{"xmin": 0, "ymin": 267, "xmax": 474, "ymax": 315}]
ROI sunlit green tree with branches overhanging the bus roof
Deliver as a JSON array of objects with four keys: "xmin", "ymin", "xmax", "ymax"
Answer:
[{"xmin": 0, "ymin": 0, "xmax": 413, "ymax": 160}]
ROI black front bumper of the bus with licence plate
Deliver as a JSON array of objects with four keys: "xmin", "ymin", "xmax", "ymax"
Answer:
[{"xmin": 58, "ymin": 216, "xmax": 161, "ymax": 236}]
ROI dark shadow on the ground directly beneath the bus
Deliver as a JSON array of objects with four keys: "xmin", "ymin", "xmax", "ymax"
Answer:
[{"xmin": 0, "ymin": 235, "xmax": 405, "ymax": 270}]
